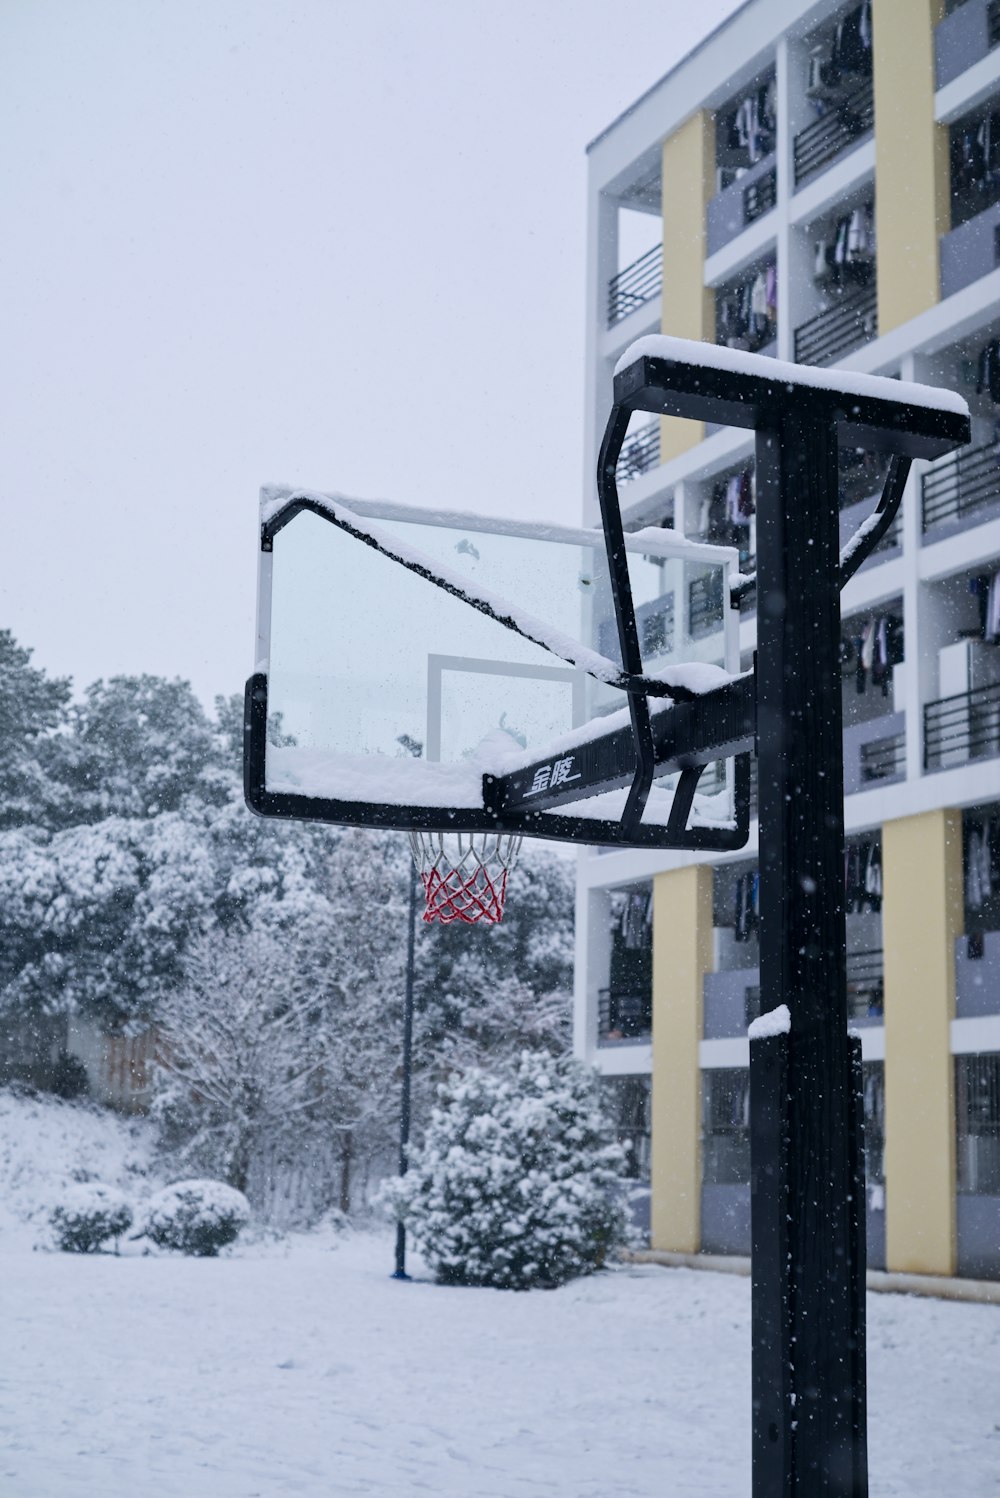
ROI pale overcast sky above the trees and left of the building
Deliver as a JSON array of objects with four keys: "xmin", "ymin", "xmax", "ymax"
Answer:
[{"xmin": 0, "ymin": 0, "xmax": 735, "ymax": 703}]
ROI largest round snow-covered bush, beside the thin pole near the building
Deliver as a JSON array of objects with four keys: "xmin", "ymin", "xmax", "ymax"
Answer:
[{"xmin": 382, "ymin": 1052, "xmax": 626, "ymax": 1290}]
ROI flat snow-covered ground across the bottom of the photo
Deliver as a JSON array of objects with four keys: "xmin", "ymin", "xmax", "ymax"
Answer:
[{"xmin": 0, "ymin": 1090, "xmax": 1000, "ymax": 1498}]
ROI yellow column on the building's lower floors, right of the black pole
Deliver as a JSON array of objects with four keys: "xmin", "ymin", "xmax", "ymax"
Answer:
[{"xmin": 882, "ymin": 810, "xmax": 963, "ymax": 1275}]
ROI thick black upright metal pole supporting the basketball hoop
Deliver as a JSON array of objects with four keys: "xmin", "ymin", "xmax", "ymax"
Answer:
[{"xmin": 750, "ymin": 409, "xmax": 867, "ymax": 1498}]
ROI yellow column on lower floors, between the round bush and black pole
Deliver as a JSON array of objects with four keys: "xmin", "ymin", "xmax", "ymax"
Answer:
[{"xmin": 651, "ymin": 864, "xmax": 713, "ymax": 1254}]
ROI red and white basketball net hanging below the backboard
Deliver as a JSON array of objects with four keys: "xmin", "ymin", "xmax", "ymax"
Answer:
[{"xmin": 410, "ymin": 831, "xmax": 521, "ymax": 926}]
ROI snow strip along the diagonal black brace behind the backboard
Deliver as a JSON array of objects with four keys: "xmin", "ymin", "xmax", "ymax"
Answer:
[{"xmin": 260, "ymin": 490, "xmax": 728, "ymax": 701}]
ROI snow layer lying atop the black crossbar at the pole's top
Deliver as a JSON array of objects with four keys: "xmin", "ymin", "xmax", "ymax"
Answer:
[{"xmin": 615, "ymin": 333, "xmax": 969, "ymax": 416}]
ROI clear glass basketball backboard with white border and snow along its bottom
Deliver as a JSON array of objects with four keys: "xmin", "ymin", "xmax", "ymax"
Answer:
[{"xmin": 247, "ymin": 488, "xmax": 748, "ymax": 846}]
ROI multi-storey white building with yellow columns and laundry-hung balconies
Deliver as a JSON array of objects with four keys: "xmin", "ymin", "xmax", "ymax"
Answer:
[{"xmin": 575, "ymin": 0, "xmax": 1000, "ymax": 1276}]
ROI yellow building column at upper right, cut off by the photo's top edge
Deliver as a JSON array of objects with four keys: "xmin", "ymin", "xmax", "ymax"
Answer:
[{"xmin": 873, "ymin": 0, "xmax": 951, "ymax": 333}]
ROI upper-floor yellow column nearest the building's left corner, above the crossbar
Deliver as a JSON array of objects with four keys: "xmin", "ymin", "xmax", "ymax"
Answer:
[{"xmin": 660, "ymin": 109, "xmax": 716, "ymax": 463}]
